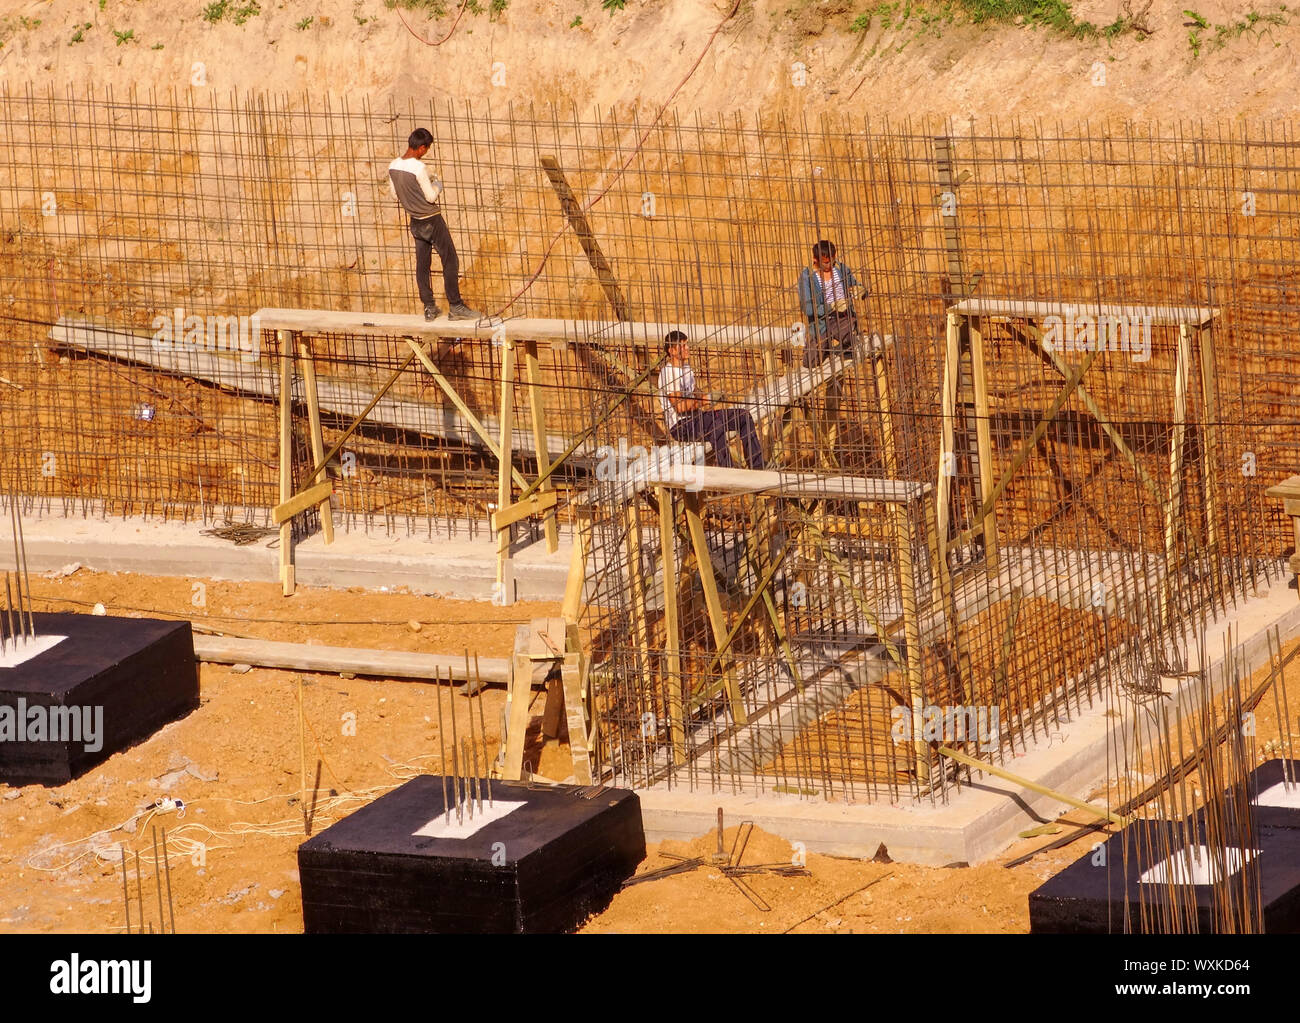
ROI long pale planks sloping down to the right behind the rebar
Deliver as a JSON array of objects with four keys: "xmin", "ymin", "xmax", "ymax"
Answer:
[{"xmin": 49, "ymin": 317, "xmax": 579, "ymax": 458}]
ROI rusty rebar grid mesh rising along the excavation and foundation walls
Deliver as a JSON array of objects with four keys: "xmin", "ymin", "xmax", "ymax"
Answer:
[{"xmin": 0, "ymin": 91, "xmax": 1300, "ymax": 798}]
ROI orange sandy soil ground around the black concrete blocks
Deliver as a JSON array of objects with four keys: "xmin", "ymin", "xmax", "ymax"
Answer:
[{"xmin": 0, "ymin": 571, "xmax": 1300, "ymax": 933}]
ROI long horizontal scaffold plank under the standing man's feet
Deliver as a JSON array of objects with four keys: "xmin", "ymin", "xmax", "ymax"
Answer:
[{"xmin": 255, "ymin": 308, "xmax": 792, "ymax": 350}]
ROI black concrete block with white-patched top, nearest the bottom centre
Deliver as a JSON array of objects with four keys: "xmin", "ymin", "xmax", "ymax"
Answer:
[{"xmin": 298, "ymin": 775, "xmax": 646, "ymax": 933}]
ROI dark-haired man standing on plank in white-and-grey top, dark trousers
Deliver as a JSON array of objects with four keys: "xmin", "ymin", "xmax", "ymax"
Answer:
[{"xmin": 389, "ymin": 127, "xmax": 481, "ymax": 320}]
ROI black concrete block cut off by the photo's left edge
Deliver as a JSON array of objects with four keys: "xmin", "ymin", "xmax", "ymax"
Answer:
[{"xmin": 0, "ymin": 614, "xmax": 199, "ymax": 785}]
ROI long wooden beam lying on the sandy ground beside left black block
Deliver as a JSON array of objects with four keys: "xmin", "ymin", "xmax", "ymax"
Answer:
[{"xmin": 194, "ymin": 633, "xmax": 510, "ymax": 684}]
